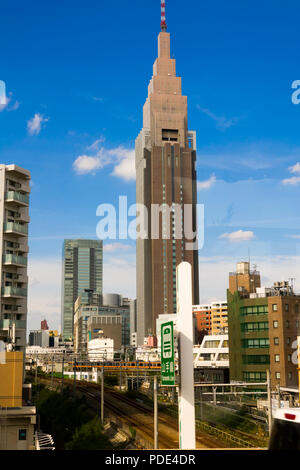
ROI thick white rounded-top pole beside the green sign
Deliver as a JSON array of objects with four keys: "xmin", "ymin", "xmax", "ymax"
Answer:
[{"xmin": 177, "ymin": 261, "xmax": 196, "ymax": 449}]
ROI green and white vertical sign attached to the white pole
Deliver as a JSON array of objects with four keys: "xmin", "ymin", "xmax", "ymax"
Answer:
[{"xmin": 161, "ymin": 321, "xmax": 175, "ymax": 385}]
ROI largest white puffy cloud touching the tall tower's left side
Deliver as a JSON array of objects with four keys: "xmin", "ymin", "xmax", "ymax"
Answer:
[{"xmin": 73, "ymin": 137, "xmax": 135, "ymax": 181}]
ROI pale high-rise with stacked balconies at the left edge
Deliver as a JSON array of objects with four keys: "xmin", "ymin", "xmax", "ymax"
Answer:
[{"xmin": 0, "ymin": 165, "xmax": 30, "ymax": 353}]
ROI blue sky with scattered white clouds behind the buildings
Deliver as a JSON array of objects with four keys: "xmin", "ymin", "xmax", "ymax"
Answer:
[{"xmin": 0, "ymin": 0, "xmax": 300, "ymax": 328}]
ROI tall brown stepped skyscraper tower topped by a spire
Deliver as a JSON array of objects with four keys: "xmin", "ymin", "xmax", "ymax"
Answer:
[{"xmin": 135, "ymin": 7, "xmax": 199, "ymax": 344}]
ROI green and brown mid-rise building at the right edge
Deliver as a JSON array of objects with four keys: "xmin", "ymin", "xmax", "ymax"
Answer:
[{"xmin": 227, "ymin": 262, "xmax": 300, "ymax": 388}]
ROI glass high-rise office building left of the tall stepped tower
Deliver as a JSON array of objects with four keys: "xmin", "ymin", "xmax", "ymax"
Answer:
[{"xmin": 61, "ymin": 239, "xmax": 103, "ymax": 339}]
